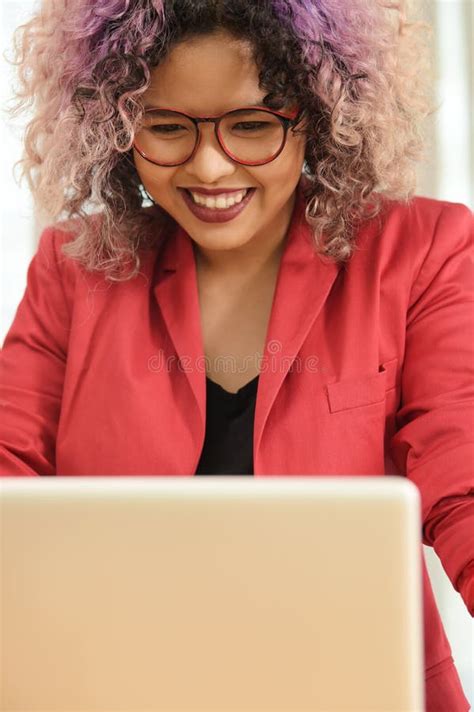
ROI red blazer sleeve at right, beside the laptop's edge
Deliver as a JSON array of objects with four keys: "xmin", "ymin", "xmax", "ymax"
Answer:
[{"xmin": 390, "ymin": 203, "xmax": 474, "ymax": 615}]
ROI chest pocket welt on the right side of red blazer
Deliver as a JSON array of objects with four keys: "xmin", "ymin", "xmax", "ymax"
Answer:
[{"xmin": 326, "ymin": 358, "xmax": 398, "ymax": 413}]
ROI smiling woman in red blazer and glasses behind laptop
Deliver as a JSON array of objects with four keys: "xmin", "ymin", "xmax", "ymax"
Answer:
[{"xmin": 0, "ymin": 0, "xmax": 474, "ymax": 712}]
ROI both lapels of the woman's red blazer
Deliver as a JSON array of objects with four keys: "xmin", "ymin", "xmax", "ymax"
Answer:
[{"xmin": 154, "ymin": 177, "xmax": 339, "ymax": 449}]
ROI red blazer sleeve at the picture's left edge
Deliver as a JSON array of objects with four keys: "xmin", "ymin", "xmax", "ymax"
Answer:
[{"xmin": 0, "ymin": 227, "xmax": 70, "ymax": 476}]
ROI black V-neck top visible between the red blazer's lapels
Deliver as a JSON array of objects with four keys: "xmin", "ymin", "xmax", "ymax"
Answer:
[{"xmin": 196, "ymin": 376, "xmax": 258, "ymax": 475}]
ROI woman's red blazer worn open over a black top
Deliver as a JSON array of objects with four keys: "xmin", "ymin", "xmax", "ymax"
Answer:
[{"xmin": 0, "ymin": 179, "xmax": 474, "ymax": 712}]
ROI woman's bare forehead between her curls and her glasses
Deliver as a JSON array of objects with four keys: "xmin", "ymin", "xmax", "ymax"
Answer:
[{"xmin": 144, "ymin": 33, "xmax": 267, "ymax": 115}]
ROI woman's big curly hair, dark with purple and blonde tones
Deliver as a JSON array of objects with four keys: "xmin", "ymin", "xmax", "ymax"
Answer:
[{"xmin": 4, "ymin": 0, "xmax": 437, "ymax": 281}]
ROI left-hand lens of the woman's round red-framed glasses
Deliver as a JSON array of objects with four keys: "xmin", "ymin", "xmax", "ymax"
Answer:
[{"xmin": 135, "ymin": 111, "xmax": 197, "ymax": 165}]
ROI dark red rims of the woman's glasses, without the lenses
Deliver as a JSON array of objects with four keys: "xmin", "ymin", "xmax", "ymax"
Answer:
[{"xmin": 133, "ymin": 106, "xmax": 301, "ymax": 168}]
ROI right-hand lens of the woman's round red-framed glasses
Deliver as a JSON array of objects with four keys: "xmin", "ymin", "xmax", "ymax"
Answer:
[{"xmin": 219, "ymin": 109, "xmax": 285, "ymax": 163}]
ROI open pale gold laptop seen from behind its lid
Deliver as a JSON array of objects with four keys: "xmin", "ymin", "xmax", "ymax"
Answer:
[{"xmin": 0, "ymin": 475, "xmax": 424, "ymax": 712}]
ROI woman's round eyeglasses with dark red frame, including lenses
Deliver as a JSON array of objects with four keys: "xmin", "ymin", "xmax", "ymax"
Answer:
[{"xmin": 133, "ymin": 107, "xmax": 300, "ymax": 167}]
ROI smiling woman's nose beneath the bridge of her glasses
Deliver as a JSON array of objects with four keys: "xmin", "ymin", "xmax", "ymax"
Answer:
[{"xmin": 183, "ymin": 123, "xmax": 238, "ymax": 183}]
